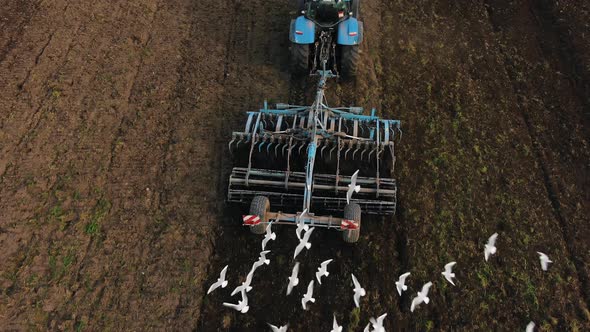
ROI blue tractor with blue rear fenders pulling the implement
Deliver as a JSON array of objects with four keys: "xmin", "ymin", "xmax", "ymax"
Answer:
[{"xmin": 289, "ymin": 0, "xmax": 363, "ymax": 78}]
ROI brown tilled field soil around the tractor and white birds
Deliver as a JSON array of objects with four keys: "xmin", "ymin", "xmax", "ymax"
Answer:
[{"xmin": 0, "ymin": 0, "xmax": 590, "ymax": 331}]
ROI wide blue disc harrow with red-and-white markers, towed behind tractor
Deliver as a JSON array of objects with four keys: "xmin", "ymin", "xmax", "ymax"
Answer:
[{"xmin": 228, "ymin": 70, "xmax": 402, "ymax": 244}]
